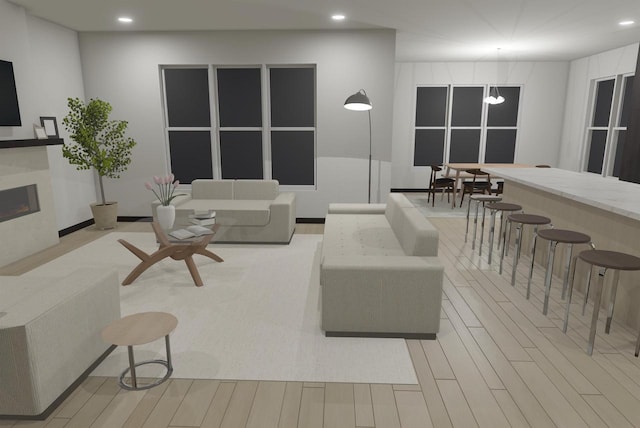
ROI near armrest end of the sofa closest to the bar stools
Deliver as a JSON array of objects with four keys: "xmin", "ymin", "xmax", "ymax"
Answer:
[{"xmin": 320, "ymin": 255, "xmax": 444, "ymax": 339}]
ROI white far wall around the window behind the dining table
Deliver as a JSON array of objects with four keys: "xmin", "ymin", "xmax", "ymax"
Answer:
[{"xmin": 391, "ymin": 62, "xmax": 569, "ymax": 188}]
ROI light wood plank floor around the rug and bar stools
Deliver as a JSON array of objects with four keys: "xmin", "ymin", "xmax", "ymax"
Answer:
[{"xmin": 0, "ymin": 218, "xmax": 640, "ymax": 428}]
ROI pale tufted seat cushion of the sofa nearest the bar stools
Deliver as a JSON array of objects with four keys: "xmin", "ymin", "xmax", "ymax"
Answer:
[{"xmin": 322, "ymin": 214, "xmax": 404, "ymax": 256}]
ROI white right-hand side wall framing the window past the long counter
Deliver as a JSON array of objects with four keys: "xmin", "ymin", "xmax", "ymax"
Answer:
[{"xmin": 558, "ymin": 43, "xmax": 639, "ymax": 171}]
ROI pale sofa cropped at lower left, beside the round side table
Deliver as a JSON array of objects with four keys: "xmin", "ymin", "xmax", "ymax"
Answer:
[{"xmin": 0, "ymin": 269, "xmax": 120, "ymax": 416}]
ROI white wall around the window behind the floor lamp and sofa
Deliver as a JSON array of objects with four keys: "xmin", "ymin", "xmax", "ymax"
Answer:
[{"xmin": 80, "ymin": 30, "xmax": 395, "ymax": 217}]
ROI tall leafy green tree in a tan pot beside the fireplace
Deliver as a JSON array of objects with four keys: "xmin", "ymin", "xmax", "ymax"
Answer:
[{"xmin": 62, "ymin": 98, "xmax": 136, "ymax": 229}]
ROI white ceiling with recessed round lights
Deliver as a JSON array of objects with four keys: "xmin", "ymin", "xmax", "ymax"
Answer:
[{"xmin": 11, "ymin": 0, "xmax": 640, "ymax": 61}]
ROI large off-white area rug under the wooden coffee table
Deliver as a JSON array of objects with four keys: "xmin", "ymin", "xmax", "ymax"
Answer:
[{"xmin": 25, "ymin": 232, "xmax": 417, "ymax": 384}]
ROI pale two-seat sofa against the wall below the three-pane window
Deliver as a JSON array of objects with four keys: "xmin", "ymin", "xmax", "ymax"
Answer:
[{"xmin": 152, "ymin": 180, "xmax": 296, "ymax": 244}]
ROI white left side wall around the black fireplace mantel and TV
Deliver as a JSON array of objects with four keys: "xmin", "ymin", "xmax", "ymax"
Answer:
[{"xmin": 0, "ymin": 0, "xmax": 96, "ymax": 230}]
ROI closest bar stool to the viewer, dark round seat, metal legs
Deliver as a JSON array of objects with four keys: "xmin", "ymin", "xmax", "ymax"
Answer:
[{"xmin": 562, "ymin": 250, "xmax": 640, "ymax": 357}]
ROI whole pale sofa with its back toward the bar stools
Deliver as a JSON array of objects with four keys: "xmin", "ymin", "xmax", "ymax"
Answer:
[{"xmin": 320, "ymin": 193, "xmax": 444, "ymax": 339}]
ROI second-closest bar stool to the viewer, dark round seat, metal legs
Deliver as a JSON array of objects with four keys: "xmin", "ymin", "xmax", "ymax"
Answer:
[{"xmin": 527, "ymin": 229, "xmax": 595, "ymax": 315}]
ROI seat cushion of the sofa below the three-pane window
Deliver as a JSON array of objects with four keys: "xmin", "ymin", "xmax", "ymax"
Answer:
[{"xmin": 178, "ymin": 199, "xmax": 273, "ymax": 226}]
